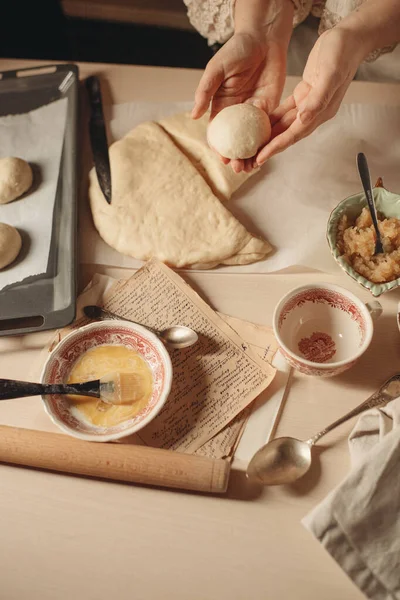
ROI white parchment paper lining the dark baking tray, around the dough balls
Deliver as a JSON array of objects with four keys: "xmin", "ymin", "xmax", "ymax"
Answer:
[{"xmin": 0, "ymin": 98, "xmax": 68, "ymax": 290}]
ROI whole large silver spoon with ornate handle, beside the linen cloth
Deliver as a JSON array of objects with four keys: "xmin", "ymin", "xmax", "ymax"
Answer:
[{"xmin": 247, "ymin": 373, "xmax": 400, "ymax": 485}]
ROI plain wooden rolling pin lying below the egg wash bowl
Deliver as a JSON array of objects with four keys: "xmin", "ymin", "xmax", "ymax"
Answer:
[{"xmin": 0, "ymin": 425, "xmax": 230, "ymax": 494}]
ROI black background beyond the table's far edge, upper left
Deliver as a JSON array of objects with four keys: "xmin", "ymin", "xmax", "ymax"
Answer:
[{"xmin": 0, "ymin": 0, "xmax": 212, "ymax": 69}]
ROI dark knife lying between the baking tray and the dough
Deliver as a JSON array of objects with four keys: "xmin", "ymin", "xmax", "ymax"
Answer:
[{"xmin": 86, "ymin": 75, "xmax": 111, "ymax": 204}]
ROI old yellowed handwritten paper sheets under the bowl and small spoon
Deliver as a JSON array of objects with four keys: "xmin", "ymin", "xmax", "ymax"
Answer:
[{"xmin": 53, "ymin": 260, "xmax": 276, "ymax": 458}]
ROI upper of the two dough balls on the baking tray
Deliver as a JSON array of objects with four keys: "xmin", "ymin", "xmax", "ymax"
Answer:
[{"xmin": 0, "ymin": 156, "xmax": 33, "ymax": 204}]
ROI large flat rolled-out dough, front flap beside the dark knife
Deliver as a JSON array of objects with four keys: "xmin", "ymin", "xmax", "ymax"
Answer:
[{"xmin": 89, "ymin": 122, "xmax": 271, "ymax": 268}]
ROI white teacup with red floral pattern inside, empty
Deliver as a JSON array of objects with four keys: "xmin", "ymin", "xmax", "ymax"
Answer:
[{"xmin": 273, "ymin": 284, "xmax": 382, "ymax": 377}]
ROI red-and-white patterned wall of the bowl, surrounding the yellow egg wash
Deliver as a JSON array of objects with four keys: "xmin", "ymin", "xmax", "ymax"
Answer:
[{"xmin": 41, "ymin": 320, "xmax": 172, "ymax": 442}]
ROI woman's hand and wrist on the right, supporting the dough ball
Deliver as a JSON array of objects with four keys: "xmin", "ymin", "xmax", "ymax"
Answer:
[{"xmin": 253, "ymin": 25, "xmax": 368, "ymax": 167}]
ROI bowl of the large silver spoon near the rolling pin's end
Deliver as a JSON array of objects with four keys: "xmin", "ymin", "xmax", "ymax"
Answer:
[{"xmin": 247, "ymin": 437, "xmax": 311, "ymax": 485}]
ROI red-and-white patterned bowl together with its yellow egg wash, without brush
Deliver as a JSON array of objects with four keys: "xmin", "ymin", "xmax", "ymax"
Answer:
[{"xmin": 41, "ymin": 320, "xmax": 172, "ymax": 442}]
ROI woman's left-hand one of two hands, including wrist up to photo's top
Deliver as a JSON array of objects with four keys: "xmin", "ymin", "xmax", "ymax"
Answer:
[{"xmin": 192, "ymin": 0, "xmax": 293, "ymax": 173}]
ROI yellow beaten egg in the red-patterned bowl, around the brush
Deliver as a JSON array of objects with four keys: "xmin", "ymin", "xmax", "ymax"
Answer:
[{"xmin": 68, "ymin": 345, "xmax": 153, "ymax": 427}]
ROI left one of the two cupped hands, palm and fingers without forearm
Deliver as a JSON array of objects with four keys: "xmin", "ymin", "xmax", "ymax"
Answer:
[{"xmin": 192, "ymin": 33, "xmax": 286, "ymax": 172}]
